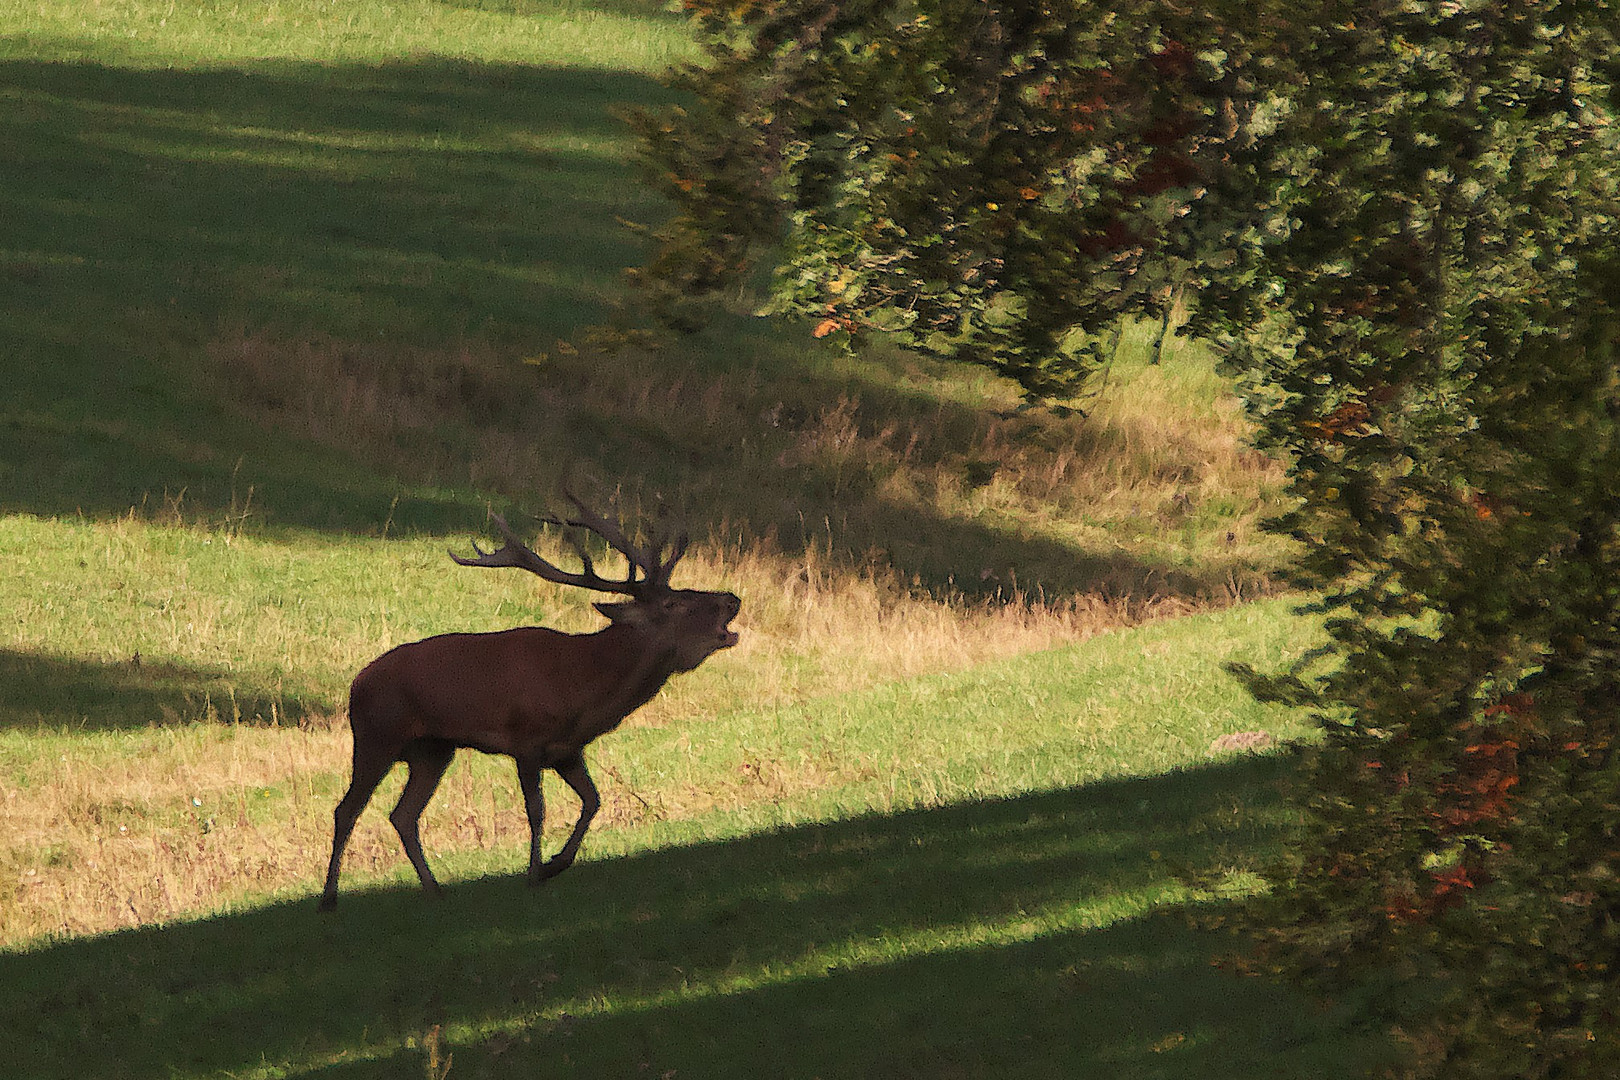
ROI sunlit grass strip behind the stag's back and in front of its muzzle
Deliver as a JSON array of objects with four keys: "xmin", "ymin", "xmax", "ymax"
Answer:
[{"xmin": 0, "ymin": 508, "xmax": 1179, "ymax": 737}]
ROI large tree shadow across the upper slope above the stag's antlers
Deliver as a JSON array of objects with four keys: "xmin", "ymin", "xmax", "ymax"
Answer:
[{"xmin": 0, "ymin": 44, "xmax": 1276, "ymax": 599}]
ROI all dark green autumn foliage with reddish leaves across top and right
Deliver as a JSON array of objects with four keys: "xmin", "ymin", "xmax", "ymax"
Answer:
[{"xmin": 650, "ymin": 0, "xmax": 1620, "ymax": 1077}]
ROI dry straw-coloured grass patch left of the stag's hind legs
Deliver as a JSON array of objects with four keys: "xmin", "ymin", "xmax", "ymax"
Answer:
[{"xmin": 0, "ymin": 725, "xmax": 336, "ymax": 944}]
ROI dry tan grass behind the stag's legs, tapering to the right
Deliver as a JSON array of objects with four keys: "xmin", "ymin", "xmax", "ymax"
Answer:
[{"xmin": 0, "ymin": 725, "xmax": 865, "ymax": 947}]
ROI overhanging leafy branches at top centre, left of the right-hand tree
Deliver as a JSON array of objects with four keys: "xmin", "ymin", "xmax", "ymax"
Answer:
[{"xmin": 638, "ymin": 0, "xmax": 1256, "ymax": 398}]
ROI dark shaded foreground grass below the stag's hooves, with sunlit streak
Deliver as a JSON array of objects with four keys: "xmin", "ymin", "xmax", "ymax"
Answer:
[{"xmin": 0, "ymin": 759, "xmax": 1388, "ymax": 1080}]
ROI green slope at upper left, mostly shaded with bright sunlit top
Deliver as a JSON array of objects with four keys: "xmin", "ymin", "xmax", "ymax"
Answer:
[{"xmin": 0, "ymin": 0, "xmax": 690, "ymax": 528}]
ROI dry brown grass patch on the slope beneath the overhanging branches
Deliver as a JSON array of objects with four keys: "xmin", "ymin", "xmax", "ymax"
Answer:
[{"xmin": 214, "ymin": 325, "xmax": 1283, "ymax": 599}]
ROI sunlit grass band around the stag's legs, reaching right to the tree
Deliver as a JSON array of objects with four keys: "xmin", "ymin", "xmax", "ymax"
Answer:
[{"xmin": 0, "ymin": 589, "xmax": 1312, "ymax": 919}]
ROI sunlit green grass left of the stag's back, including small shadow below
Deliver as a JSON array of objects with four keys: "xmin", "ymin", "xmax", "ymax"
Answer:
[{"xmin": 0, "ymin": 517, "xmax": 537, "ymax": 730}]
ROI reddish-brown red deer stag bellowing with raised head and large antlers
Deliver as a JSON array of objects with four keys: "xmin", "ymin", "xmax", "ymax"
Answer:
[{"xmin": 321, "ymin": 491, "xmax": 742, "ymax": 912}]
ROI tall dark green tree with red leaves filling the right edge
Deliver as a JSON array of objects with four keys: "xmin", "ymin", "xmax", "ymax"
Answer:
[{"xmin": 1226, "ymin": 3, "xmax": 1620, "ymax": 1077}]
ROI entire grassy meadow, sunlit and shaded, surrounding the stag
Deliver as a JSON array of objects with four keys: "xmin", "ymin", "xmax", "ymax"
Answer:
[{"xmin": 0, "ymin": 0, "xmax": 1390, "ymax": 1080}]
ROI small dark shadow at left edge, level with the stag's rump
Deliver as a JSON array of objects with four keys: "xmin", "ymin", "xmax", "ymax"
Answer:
[{"xmin": 0, "ymin": 649, "xmax": 326, "ymax": 730}]
